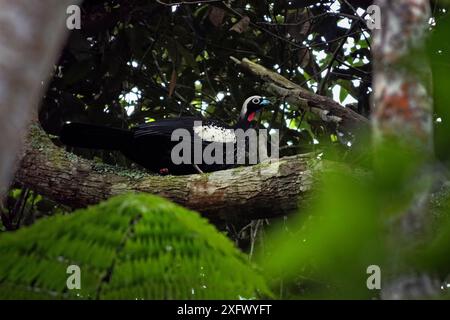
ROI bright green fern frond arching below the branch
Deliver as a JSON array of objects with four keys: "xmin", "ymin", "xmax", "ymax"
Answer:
[{"xmin": 0, "ymin": 194, "xmax": 270, "ymax": 299}]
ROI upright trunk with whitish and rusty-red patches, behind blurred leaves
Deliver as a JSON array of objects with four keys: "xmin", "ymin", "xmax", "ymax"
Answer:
[{"xmin": 372, "ymin": 0, "xmax": 439, "ymax": 299}]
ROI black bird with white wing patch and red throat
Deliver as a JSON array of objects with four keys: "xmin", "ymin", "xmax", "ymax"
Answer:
[{"xmin": 60, "ymin": 96, "xmax": 269, "ymax": 175}]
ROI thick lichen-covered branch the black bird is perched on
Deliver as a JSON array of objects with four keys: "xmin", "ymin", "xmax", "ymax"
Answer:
[{"xmin": 15, "ymin": 125, "xmax": 318, "ymax": 220}]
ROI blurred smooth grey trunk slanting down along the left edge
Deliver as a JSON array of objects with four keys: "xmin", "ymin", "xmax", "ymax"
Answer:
[{"xmin": 0, "ymin": 0, "xmax": 78, "ymax": 197}]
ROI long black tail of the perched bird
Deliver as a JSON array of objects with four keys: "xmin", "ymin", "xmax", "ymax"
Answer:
[{"xmin": 59, "ymin": 123, "xmax": 132, "ymax": 150}]
